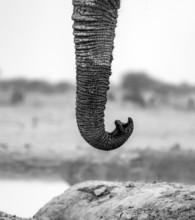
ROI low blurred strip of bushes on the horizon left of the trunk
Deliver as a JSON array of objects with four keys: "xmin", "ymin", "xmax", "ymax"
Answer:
[{"xmin": 0, "ymin": 78, "xmax": 75, "ymax": 106}]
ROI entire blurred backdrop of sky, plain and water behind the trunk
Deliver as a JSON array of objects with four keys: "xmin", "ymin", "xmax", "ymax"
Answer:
[{"xmin": 0, "ymin": 0, "xmax": 195, "ymax": 217}]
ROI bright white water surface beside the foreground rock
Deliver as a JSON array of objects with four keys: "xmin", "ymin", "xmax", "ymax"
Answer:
[{"xmin": 0, "ymin": 180, "xmax": 69, "ymax": 218}]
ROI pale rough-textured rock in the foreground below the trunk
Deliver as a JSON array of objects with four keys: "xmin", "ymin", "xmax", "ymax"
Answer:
[{"xmin": 0, "ymin": 181, "xmax": 195, "ymax": 220}]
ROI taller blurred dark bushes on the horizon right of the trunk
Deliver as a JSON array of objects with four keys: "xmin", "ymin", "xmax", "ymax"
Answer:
[{"xmin": 120, "ymin": 72, "xmax": 195, "ymax": 110}]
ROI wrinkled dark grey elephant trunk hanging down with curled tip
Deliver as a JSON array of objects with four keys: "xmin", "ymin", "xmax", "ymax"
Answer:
[{"xmin": 72, "ymin": 0, "xmax": 133, "ymax": 151}]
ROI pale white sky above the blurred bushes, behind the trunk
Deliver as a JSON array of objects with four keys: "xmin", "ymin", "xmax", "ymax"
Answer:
[{"xmin": 0, "ymin": 0, "xmax": 195, "ymax": 84}]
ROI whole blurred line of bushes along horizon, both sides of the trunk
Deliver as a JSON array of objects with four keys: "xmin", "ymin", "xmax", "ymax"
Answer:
[{"xmin": 0, "ymin": 75, "xmax": 195, "ymax": 111}]
